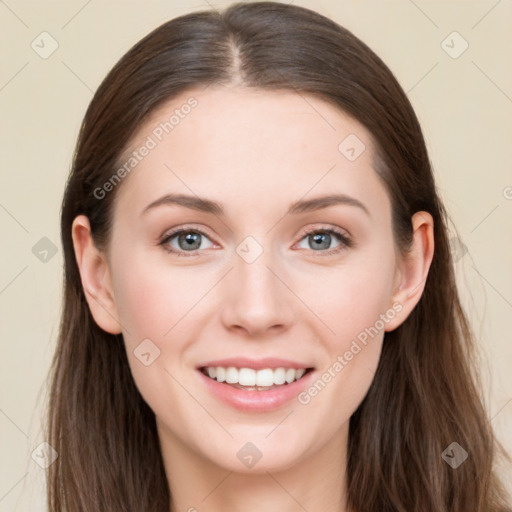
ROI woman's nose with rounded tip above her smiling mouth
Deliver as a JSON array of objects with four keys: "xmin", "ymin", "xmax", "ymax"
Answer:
[{"xmin": 221, "ymin": 243, "xmax": 294, "ymax": 337}]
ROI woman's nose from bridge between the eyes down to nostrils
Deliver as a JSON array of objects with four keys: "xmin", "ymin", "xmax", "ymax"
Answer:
[{"xmin": 223, "ymin": 236, "xmax": 293, "ymax": 334}]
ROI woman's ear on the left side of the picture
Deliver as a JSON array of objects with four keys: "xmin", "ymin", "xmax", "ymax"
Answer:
[{"xmin": 71, "ymin": 215, "xmax": 121, "ymax": 334}]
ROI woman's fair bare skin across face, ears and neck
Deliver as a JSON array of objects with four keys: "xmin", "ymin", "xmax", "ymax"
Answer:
[{"xmin": 72, "ymin": 86, "xmax": 434, "ymax": 512}]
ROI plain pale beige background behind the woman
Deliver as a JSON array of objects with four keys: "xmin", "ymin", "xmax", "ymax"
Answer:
[{"xmin": 0, "ymin": 0, "xmax": 512, "ymax": 512}]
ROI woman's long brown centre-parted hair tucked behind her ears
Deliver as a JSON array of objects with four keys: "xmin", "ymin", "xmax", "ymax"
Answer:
[{"xmin": 48, "ymin": 2, "xmax": 507, "ymax": 512}]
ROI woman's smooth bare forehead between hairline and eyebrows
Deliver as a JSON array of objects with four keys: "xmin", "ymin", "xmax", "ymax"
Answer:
[{"xmin": 113, "ymin": 86, "xmax": 386, "ymax": 224}]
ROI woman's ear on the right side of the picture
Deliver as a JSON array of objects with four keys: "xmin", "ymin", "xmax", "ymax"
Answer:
[{"xmin": 385, "ymin": 211, "xmax": 434, "ymax": 331}]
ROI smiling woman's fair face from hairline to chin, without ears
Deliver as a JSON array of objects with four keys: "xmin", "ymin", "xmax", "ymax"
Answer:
[{"xmin": 87, "ymin": 87, "xmax": 412, "ymax": 471}]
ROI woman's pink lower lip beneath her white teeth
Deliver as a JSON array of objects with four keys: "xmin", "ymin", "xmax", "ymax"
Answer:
[{"xmin": 198, "ymin": 370, "xmax": 315, "ymax": 412}]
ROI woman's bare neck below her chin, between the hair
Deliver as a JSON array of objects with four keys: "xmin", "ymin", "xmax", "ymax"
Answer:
[{"xmin": 159, "ymin": 424, "xmax": 348, "ymax": 512}]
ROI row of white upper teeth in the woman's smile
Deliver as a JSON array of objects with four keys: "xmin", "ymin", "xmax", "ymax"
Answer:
[{"xmin": 205, "ymin": 366, "xmax": 306, "ymax": 387}]
